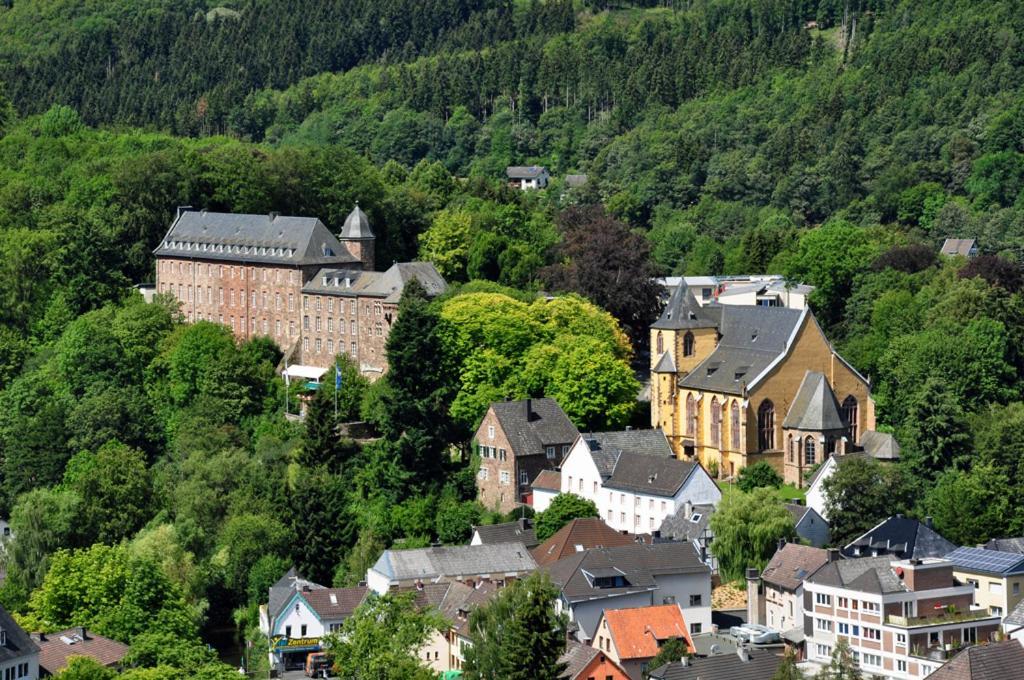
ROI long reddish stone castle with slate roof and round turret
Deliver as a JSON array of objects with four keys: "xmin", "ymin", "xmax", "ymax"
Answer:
[{"xmin": 155, "ymin": 206, "xmax": 444, "ymax": 378}]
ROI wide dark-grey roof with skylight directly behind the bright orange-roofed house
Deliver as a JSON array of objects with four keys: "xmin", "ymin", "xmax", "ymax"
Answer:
[{"xmin": 544, "ymin": 543, "xmax": 711, "ymax": 602}]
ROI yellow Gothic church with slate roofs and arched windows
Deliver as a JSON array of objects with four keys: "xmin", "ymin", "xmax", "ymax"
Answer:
[{"xmin": 650, "ymin": 283, "xmax": 874, "ymax": 483}]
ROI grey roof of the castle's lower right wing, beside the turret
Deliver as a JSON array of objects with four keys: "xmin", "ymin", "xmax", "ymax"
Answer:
[{"xmin": 302, "ymin": 262, "xmax": 447, "ymax": 302}]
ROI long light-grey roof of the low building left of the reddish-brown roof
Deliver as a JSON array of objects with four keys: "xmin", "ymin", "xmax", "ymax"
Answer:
[{"xmin": 373, "ymin": 543, "xmax": 537, "ymax": 581}]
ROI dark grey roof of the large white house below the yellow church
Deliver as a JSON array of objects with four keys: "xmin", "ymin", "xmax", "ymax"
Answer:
[{"xmin": 583, "ymin": 429, "xmax": 697, "ymax": 497}]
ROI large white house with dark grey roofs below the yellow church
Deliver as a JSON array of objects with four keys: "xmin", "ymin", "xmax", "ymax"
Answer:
[{"xmin": 560, "ymin": 430, "xmax": 722, "ymax": 534}]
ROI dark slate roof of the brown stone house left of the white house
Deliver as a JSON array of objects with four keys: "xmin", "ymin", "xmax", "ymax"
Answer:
[{"xmin": 490, "ymin": 397, "xmax": 580, "ymax": 456}]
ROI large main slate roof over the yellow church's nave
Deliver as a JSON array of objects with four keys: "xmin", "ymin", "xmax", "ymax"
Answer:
[{"xmin": 679, "ymin": 304, "xmax": 805, "ymax": 394}]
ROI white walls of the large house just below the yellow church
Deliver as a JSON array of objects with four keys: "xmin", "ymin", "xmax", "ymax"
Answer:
[{"xmin": 561, "ymin": 436, "xmax": 722, "ymax": 534}]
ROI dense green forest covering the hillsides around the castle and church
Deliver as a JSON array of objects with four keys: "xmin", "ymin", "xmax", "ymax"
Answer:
[{"xmin": 0, "ymin": 0, "xmax": 1024, "ymax": 677}]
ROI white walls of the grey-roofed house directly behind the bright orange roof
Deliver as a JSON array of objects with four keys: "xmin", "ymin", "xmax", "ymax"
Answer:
[{"xmin": 555, "ymin": 572, "xmax": 711, "ymax": 643}]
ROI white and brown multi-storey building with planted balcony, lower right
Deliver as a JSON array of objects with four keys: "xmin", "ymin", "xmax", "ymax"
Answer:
[{"xmin": 803, "ymin": 555, "xmax": 999, "ymax": 680}]
